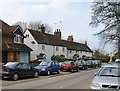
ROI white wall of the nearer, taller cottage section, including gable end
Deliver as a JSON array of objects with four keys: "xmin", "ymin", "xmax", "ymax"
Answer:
[{"xmin": 24, "ymin": 30, "xmax": 67, "ymax": 60}]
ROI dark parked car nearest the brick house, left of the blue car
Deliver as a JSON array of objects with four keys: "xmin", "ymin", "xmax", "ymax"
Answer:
[{"xmin": 2, "ymin": 62, "xmax": 38, "ymax": 80}]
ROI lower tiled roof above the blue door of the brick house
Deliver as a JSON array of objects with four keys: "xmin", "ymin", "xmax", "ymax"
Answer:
[{"xmin": 2, "ymin": 43, "xmax": 32, "ymax": 51}]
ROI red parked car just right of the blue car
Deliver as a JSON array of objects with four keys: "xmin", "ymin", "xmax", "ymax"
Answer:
[{"xmin": 61, "ymin": 61, "xmax": 79, "ymax": 72}]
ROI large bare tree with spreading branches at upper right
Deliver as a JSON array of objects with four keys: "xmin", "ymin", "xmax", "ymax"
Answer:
[{"xmin": 90, "ymin": 1, "xmax": 120, "ymax": 57}]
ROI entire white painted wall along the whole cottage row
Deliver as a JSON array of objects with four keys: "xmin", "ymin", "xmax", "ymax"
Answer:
[{"xmin": 24, "ymin": 30, "xmax": 92, "ymax": 60}]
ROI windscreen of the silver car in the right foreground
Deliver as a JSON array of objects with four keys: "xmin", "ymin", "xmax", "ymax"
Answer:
[{"xmin": 98, "ymin": 67, "xmax": 120, "ymax": 77}]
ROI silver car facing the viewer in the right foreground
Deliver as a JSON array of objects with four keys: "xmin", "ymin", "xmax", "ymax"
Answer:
[{"xmin": 91, "ymin": 63, "xmax": 120, "ymax": 91}]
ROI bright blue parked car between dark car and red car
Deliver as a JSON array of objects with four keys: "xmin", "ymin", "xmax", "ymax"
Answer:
[{"xmin": 35, "ymin": 60, "xmax": 60, "ymax": 75}]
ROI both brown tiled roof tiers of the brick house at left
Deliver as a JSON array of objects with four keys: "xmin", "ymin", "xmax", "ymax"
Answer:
[{"xmin": 0, "ymin": 20, "xmax": 32, "ymax": 51}]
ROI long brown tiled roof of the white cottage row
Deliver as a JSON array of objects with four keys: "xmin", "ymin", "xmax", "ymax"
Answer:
[{"xmin": 28, "ymin": 29, "xmax": 92, "ymax": 52}]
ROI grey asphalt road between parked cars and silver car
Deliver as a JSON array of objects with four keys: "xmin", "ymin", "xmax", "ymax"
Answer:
[{"xmin": 3, "ymin": 69, "xmax": 98, "ymax": 89}]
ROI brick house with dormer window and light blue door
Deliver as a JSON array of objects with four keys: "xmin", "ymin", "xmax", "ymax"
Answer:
[{"xmin": 0, "ymin": 20, "xmax": 32, "ymax": 63}]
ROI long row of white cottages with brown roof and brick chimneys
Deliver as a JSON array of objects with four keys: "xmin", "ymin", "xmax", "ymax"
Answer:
[{"xmin": 24, "ymin": 24, "xmax": 93, "ymax": 60}]
